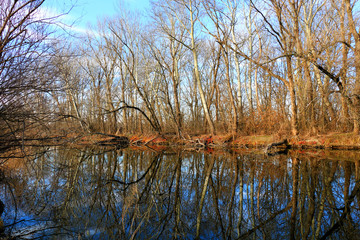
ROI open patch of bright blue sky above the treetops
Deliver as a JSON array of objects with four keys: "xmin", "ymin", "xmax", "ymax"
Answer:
[{"xmin": 43, "ymin": 0, "xmax": 150, "ymax": 32}]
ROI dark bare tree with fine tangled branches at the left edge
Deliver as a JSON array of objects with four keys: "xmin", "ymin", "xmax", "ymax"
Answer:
[{"xmin": 0, "ymin": 0, "xmax": 68, "ymax": 142}]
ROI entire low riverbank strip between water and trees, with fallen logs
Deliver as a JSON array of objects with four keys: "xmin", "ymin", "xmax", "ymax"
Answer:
[{"xmin": 0, "ymin": 133, "xmax": 360, "ymax": 150}]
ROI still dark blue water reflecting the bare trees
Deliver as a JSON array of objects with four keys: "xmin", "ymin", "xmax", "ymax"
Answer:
[{"xmin": 0, "ymin": 148, "xmax": 360, "ymax": 240}]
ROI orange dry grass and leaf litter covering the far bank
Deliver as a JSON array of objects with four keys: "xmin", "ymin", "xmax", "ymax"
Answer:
[{"xmin": 7, "ymin": 130, "xmax": 360, "ymax": 149}]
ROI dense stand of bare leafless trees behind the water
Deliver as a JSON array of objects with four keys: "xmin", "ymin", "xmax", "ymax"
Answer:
[{"xmin": 0, "ymin": 0, "xmax": 360, "ymax": 143}]
